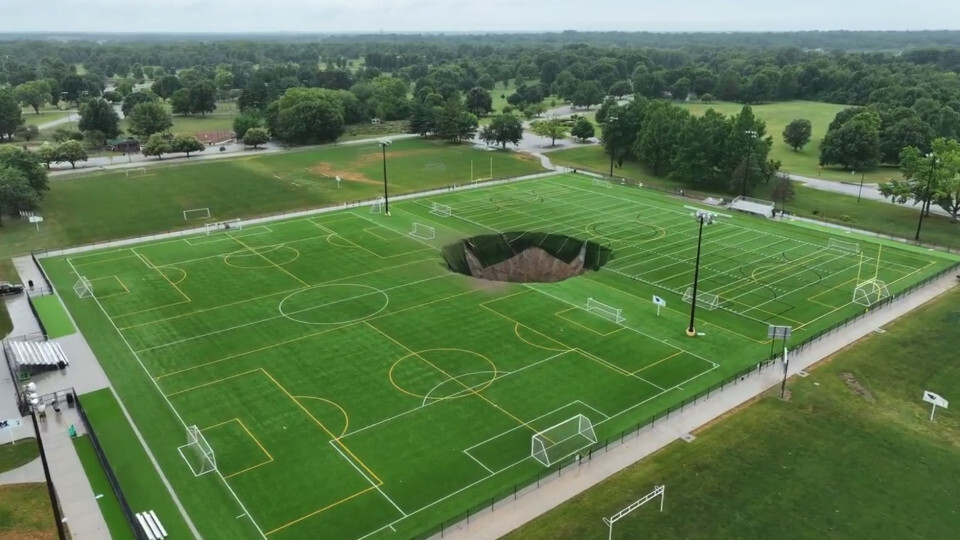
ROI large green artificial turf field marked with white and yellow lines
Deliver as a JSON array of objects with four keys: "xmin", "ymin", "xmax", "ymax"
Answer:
[{"xmin": 42, "ymin": 175, "xmax": 956, "ymax": 539}]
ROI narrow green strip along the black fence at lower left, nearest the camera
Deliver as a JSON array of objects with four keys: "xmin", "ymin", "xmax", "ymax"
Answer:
[{"xmin": 74, "ymin": 390, "xmax": 192, "ymax": 538}]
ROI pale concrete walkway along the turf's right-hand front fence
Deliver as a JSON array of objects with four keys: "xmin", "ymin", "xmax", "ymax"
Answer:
[{"xmin": 433, "ymin": 274, "xmax": 957, "ymax": 540}]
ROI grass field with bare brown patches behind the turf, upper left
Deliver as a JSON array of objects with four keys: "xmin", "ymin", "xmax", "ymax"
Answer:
[{"xmin": 0, "ymin": 139, "xmax": 542, "ymax": 255}]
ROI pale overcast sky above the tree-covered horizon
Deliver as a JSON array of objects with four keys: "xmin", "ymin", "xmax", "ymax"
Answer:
[{"xmin": 7, "ymin": 0, "xmax": 960, "ymax": 33}]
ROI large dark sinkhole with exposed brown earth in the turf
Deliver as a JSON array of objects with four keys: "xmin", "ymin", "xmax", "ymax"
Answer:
[{"xmin": 442, "ymin": 232, "xmax": 613, "ymax": 283}]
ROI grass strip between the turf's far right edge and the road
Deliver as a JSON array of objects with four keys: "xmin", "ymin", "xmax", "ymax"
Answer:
[{"xmin": 550, "ymin": 145, "xmax": 960, "ymax": 248}]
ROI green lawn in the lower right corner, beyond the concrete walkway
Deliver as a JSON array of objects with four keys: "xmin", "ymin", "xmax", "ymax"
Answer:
[{"xmin": 506, "ymin": 290, "xmax": 960, "ymax": 540}]
